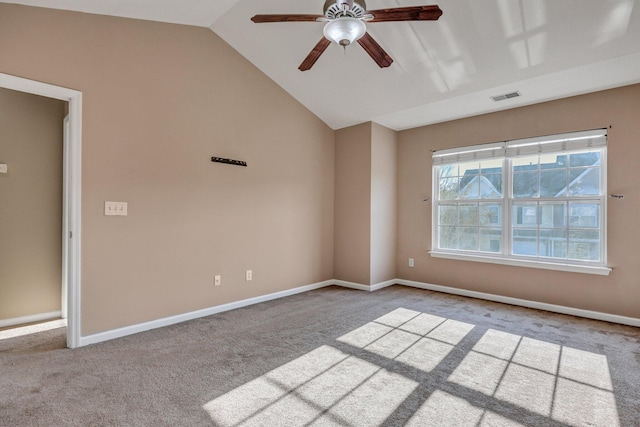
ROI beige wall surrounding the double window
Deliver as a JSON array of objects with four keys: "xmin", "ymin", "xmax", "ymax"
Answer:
[{"xmin": 398, "ymin": 85, "xmax": 640, "ymax": 317}]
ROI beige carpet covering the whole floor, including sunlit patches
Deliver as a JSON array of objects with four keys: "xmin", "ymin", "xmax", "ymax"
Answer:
[{"xmin": 0, "ymin": 286, "xmax": 640, "ymax": 427}]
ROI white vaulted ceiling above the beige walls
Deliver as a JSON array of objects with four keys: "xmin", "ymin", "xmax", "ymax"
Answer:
[{"xmin": 4, "ymin": 0, "xmax": 640, "ymax": 130}]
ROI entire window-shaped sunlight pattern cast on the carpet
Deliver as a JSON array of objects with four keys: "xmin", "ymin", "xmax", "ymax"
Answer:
[{"xmin": 203, "ymin": 308, "xmax": 620, "ymax": 427}]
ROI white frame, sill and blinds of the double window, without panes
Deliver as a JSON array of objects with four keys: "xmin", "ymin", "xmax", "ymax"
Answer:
[{"xmin": 429, "ymin": 129, "xmax": 612, "ymax": 275}]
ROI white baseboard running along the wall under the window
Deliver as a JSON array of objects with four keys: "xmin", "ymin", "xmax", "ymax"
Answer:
[{"xmin": 395, "ymin": 279, "xmax": 640, "ymax": 327}]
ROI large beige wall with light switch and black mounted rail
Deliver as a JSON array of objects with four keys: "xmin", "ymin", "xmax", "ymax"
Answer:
[{"xmin": 0, "ymin": 3, "xmax": 335, "ymax": 335}]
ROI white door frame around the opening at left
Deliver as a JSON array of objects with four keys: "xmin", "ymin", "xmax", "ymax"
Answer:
[{"xmin": 0, "ymin": 73, "xmax": 82, "ymax": 348}]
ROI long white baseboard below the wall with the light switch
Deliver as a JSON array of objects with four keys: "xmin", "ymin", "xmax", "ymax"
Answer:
[{"xmin": 80, "ymin": 280, "xmax": 334, "ymax": 347}]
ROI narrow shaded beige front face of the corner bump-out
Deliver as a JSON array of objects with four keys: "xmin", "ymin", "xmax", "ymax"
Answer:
[{"xmin": 333, "ymin": 123, "xmax": 372, "ymax": 285}]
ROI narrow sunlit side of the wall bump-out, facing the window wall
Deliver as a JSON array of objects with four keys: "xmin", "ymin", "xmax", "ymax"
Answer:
[{"xmin": 370, "ymin": 123, "xmax": 398, "ymax": 284}]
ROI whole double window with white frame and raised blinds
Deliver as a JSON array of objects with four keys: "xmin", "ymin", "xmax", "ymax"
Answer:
[{"xmin": 431, "ymin": 129, "xmax": 610, "ymax": 274}]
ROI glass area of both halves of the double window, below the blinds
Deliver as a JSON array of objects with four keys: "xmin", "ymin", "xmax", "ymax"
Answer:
[{"xmin": 434, "ymin": 145, "xmax": 606, "ymax": 264}]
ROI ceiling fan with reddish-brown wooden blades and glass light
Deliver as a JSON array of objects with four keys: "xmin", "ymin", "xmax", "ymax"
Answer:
[{"xmin": 251, "ymin": 0, "xmax": 442, "ymax": 71}]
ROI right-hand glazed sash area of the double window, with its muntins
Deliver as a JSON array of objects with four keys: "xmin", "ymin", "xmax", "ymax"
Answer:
[{"xmin": 509, "ymin": 150, "xmax": 602, "ymax": 262}]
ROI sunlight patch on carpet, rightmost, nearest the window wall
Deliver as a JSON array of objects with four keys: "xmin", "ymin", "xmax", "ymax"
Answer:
[{"xmin": 448, "ymin": 329, "xmax": 619, "ymax": 426}]
